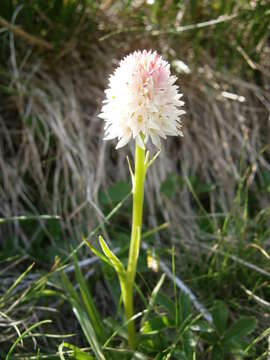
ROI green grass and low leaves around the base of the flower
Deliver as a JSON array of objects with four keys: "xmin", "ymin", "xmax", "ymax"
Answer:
[{"xmin": 0, "ymin": 166, "xmax": 270, "ymax": 359}]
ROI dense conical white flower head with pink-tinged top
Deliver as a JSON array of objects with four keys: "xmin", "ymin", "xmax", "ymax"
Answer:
[{"xmin": 99, "ymin": 50, "xmax": 185, "ymax": 148}]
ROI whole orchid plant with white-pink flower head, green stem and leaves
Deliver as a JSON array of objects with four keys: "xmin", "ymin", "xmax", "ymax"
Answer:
[{"xmin": 87, "ymin": 50, "xmax": 185, "ymax": 348}]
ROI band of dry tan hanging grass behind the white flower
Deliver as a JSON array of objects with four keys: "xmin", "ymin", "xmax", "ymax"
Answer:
[{"xmin": 0, "ymin": 27, "xmax": 270, "ymax": 253}]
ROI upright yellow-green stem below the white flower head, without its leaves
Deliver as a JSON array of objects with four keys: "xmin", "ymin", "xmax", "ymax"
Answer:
[{"xmin": 124, "ymin": 145, "xmax": 146, "ymax": 349}]
